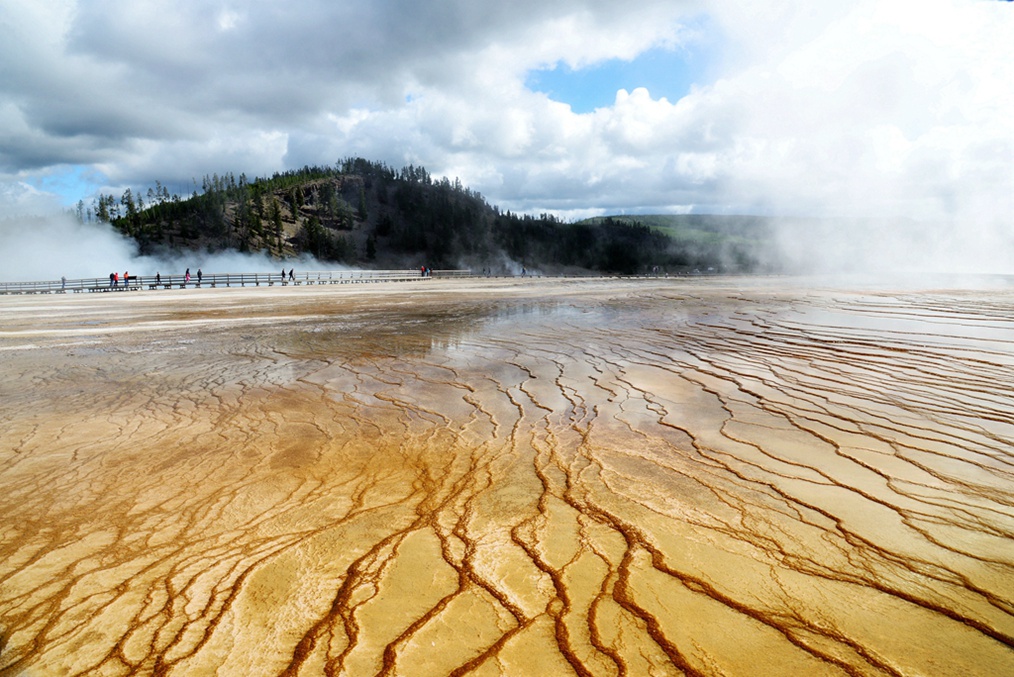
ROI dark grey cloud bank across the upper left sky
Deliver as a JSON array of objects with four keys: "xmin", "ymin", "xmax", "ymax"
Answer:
[{"xmin": 0, "ymin": 0, "xmax": 685, "ymax": 184}]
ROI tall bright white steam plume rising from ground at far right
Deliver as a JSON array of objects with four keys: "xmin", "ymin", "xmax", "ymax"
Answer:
[{"xmin": 706, "ymin": 0, "xmax": 1014, "ymax": 274}]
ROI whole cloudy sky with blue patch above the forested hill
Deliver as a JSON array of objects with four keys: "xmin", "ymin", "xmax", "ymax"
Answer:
[{"xmin": 0, "ymin": 0, "xmax": 1014, "ymax": 275}]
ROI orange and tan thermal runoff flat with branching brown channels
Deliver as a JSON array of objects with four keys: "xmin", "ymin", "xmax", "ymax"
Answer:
[{"xmin": 0, "ymin": 279, "xmax": 1014, "ymax": 676}]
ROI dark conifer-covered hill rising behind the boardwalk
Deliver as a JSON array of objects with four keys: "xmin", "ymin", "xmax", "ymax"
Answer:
[{"xmin": 77, "ymin": 158, "xmax": 763, "ymax": 275}]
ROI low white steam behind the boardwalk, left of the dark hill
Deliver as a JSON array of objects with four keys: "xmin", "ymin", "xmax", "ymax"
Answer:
[{"xmin": 0, "ymin": 215, "xmax": 340, "ymax": 282}]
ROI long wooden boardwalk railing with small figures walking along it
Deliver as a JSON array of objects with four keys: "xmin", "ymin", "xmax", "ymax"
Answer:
[{"xmin": 0, "ymin": 270, "xmax": 472, "ymax": 294}]
